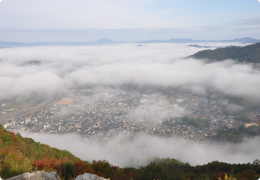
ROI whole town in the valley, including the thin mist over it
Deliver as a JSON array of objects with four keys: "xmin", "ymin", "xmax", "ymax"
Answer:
[{"xmin": 0, "ymin": 86, "xmax": 260, "ymax": 143}]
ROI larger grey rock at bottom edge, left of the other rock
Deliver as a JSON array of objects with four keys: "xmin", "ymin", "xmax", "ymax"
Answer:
[{"xmin": 7, "ymin": 171, "xmax": 60, "ymax": 180}]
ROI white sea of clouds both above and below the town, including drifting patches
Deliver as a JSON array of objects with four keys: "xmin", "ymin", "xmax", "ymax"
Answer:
[{"xmin": 0, "ymin": 43, "xmax": 260, "ymax": 167}]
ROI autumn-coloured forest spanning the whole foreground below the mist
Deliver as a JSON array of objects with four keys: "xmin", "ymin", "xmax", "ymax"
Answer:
[{"xmin": 0, "ymin": 125, "xmax": 260, "ymax": 180}]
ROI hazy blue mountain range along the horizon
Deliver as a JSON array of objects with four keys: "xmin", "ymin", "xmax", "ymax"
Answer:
[{"xmin": 0, "ymin": 37, "xmax": 260, "ymax": 48}]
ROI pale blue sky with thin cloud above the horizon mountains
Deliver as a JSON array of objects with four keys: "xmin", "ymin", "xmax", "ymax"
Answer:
[{"xmin": 0, "ymin": 0, "xmax": 260, "ymax": 42}]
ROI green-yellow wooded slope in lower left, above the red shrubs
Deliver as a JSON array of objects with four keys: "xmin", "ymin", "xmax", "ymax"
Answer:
[{"xmin": 0, "ymin": 124, "xmax": 79, "ymax": 178}]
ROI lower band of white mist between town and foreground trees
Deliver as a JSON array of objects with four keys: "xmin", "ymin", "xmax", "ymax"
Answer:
[{"xmin": 22, "ymin": 133, "xmax": 260, "ymax": 167}]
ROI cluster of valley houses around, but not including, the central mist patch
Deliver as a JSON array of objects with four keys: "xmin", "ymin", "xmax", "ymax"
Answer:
[{"xmin": 4, "ymin": 89, "xmax": 259, "ymax": 143}]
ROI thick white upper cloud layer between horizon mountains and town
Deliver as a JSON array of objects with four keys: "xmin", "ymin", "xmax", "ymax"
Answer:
[{"xmin": 0, "ymin": 44, "xmax": 260, "ymax": 100}]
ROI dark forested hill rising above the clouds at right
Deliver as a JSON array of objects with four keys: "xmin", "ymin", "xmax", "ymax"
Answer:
[{"xmin": 189, "ymin": 43, "xmax": 260, "ymax": 63}]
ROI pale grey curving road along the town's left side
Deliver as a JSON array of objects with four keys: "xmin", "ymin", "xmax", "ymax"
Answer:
[{"xmin": 0, "ymin": 93, "xmax": 56, "ymax": 122}]
